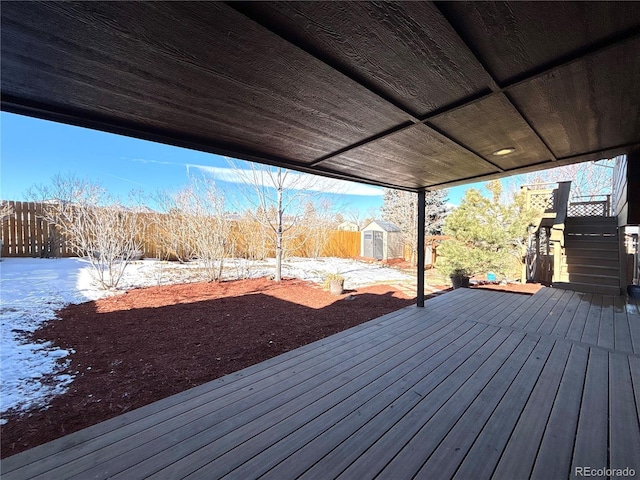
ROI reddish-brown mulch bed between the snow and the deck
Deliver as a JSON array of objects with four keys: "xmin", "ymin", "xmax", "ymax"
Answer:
[{"xmin": 0, "ymin": 278, "xmax": 413, "ymax": 458}]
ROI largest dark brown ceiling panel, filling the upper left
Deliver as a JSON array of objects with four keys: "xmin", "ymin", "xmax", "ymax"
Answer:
[{"xmin": 2, "ymin": 2, "xmax": 407, "ymax": 162}]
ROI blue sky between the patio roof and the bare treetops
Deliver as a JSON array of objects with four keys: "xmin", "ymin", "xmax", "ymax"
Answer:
[{"xmin": 0, "ymin": 112, "xmax": 469, "ymax": 214}]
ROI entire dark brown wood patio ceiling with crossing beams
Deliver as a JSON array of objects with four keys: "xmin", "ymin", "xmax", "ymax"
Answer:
[{"xmin": 1, "ymin": 2, "xmax": 640, "ymax": 190}]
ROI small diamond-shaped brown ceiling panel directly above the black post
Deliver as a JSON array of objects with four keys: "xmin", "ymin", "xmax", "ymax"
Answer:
[{"xmin": 322, "ymin": 125, "xmax": 497, "ymax": 188}]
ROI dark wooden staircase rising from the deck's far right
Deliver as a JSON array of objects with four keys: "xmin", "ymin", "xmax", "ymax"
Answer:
[{"xmin": 553, "ymin": 217, "xmax": 620, "ymax": 295}]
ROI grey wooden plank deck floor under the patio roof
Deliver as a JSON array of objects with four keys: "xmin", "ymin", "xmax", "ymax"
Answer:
[{"xmin": 2, "ymin": 288, "xmax": 640, "ymax": 480}]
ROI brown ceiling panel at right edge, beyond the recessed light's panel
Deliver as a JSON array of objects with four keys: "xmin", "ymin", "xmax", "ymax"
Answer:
[{"xmin": 509, "ymin": 39, "xmax": 640, "ymax": 158}]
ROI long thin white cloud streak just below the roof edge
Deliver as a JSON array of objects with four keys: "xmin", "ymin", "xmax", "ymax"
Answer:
[{"xmin": 187, "ymin": 164, "xmax": 383, "ymax": 197}]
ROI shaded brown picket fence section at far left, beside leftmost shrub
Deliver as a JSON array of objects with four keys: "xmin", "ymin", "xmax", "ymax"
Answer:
[{"xmin": 2, "ymin": 201, "xmax": 74, "ymax": 257}]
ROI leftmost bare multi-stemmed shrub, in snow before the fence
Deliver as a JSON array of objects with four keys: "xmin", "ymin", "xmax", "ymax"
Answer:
[{"xmin": 30, "ymin": 174, "xmax": 142, "ymax": 289}]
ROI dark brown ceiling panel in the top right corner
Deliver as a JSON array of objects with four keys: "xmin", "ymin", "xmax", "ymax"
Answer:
[{"xmin": 438, "ymin": 1, "xmax": 640, "ymax": 84}]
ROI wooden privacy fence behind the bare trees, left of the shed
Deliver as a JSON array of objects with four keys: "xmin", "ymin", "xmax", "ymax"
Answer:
[{"xmin": 1, "ymin": 201, "xmax": 360, "ymax": 258}]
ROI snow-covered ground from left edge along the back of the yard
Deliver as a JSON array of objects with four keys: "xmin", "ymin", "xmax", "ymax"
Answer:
[{"xmin": 0, "ymin": 258, "xmax": 414, "ymax": 423}]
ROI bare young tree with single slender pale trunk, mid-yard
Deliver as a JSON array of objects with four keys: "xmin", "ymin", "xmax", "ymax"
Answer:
[{"xmin": 229, "ymin": 161, "xmax": 330, "ymax": 282}]
